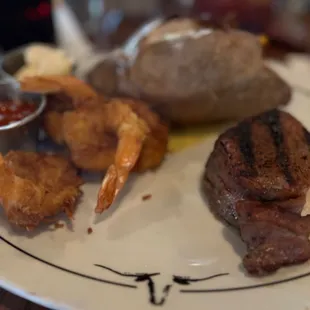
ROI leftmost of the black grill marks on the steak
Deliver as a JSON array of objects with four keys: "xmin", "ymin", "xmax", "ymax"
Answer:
[{"xmin": 235, "ymin": 121, "xmax": 257, "ymax": 177}]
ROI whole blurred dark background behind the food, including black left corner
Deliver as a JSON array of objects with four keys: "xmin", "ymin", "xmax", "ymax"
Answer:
[{"xmin": 0, "ymin": 0, "xmax": 310, "ymax": 51}]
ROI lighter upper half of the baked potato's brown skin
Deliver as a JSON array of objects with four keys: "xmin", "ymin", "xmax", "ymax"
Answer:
[{"xmin": 130, "ymin": 30, "xmax": 263, "ymax": 99}]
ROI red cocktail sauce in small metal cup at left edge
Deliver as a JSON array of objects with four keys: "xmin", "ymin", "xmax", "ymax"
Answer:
[{"xmin": 0, "ymin": 101, "xmax": 37, "ymax": 126}]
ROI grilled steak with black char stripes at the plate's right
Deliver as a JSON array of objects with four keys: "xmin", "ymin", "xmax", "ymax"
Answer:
[{"xmin": 203, "ymin": 110, "xmax": 310, "ymax": 275}]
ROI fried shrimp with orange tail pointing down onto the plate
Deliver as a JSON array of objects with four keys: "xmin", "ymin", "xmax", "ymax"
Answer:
[{"xmin": 63, "ymin": 99, "xmax": 168, "ymax": 213}]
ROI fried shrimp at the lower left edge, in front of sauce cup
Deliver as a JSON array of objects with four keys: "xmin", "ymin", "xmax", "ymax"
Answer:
[{"xmin": 0, "ymin": 151, "xmax": 82, "ymax": 230}]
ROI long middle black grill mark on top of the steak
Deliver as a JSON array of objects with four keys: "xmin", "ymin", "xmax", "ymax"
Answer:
[{"xmin": 259, "ymin": 110, "xmax": 294, "ymax": 185}]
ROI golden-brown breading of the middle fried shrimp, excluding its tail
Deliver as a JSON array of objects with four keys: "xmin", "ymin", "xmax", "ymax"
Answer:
[{"xmin": 63, "ymin": 99, "xmax": 168, "ymax": 172}]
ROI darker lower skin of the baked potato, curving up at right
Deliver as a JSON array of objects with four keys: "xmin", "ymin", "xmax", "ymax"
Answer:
[{"xmin": 155, "ymin": 67, "xmax": 292, "ymax": 126}]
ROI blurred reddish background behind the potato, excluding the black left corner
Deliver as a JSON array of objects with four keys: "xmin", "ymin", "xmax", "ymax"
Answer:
[{"xmin": 68, "ymin": 0, "xmax": 310, "ymax": 51}]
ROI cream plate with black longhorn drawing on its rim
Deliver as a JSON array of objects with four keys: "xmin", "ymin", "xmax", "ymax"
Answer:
[{"xmin": 0, "ymin": 75, "xmax": 310, "ymax": 310}]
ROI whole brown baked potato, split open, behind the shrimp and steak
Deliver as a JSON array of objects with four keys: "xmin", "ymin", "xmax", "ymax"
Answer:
[{"xmin": 88, "ymin": 18, "xmax": 291, "ymax": 125}]
